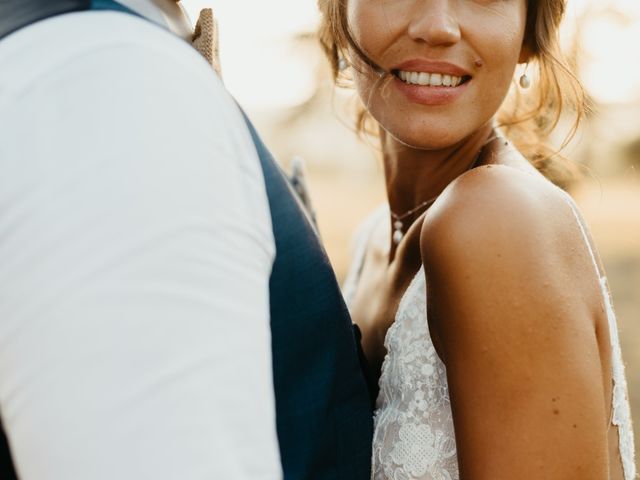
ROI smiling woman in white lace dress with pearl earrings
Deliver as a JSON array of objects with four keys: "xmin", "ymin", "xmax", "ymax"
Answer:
[{"xmin": 319, "ymin": 0, "xmax": 635, "ymax": 480}]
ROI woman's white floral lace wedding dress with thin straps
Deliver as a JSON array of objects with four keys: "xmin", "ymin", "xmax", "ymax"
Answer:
[{"xmin": 344, "ymin": 195, "xmax": 636, "ymax": 480}]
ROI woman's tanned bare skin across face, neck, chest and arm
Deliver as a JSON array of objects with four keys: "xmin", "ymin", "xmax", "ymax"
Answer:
[{"xmin": 348, "ymin": 0, "xmax": 623, "ymax": 480}]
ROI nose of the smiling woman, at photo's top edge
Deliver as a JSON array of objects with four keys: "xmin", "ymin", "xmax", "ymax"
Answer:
[{"xmin": 407, "ymin": 0, "xmax": 460, "ymax": 47}]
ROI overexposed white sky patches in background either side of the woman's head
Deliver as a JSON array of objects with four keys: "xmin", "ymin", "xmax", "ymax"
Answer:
[{"xmin": 182, "ymin": 0, "xmax": 640, "ymax": 110}]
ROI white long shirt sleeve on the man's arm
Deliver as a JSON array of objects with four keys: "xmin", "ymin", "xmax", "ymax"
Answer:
[{"xmin": 0, "ymin": 15, "xmax": 281, "ymax": 480}]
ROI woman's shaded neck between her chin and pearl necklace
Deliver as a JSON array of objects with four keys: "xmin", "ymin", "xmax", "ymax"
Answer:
[{"xmin": 380, "ymin": 123, "xmax": 493, "ymax": 242}]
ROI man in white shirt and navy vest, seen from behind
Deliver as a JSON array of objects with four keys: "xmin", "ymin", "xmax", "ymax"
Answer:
[{"xmin": 0, "ymin": 0, "xmax": 372, "ymax": 480}]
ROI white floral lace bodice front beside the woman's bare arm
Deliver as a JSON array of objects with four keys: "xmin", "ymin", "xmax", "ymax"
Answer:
[{"xmin": 372, "ymin": 269, "xmax": 459, "ymax": 480}]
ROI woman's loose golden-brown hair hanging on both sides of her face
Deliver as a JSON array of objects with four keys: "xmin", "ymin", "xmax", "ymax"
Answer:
[{"xmin": 318, "ymin": 0, "xmax": 586, "ymax": 185}]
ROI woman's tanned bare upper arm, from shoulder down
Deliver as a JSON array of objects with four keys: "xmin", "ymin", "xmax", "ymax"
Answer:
[{"xmin": 422, "ymin": 168, "xmax": 607, "ymax": 480}]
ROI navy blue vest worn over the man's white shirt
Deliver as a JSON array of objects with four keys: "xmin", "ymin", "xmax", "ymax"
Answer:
[{"xmin": 0, "ymin": 0, "xmax": 373, "ymax": 480}]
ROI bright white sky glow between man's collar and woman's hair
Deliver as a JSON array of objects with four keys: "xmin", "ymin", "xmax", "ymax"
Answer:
[{"xmin": 183, "ymin": 0, "xmax": 317, "ymax": 110}]
